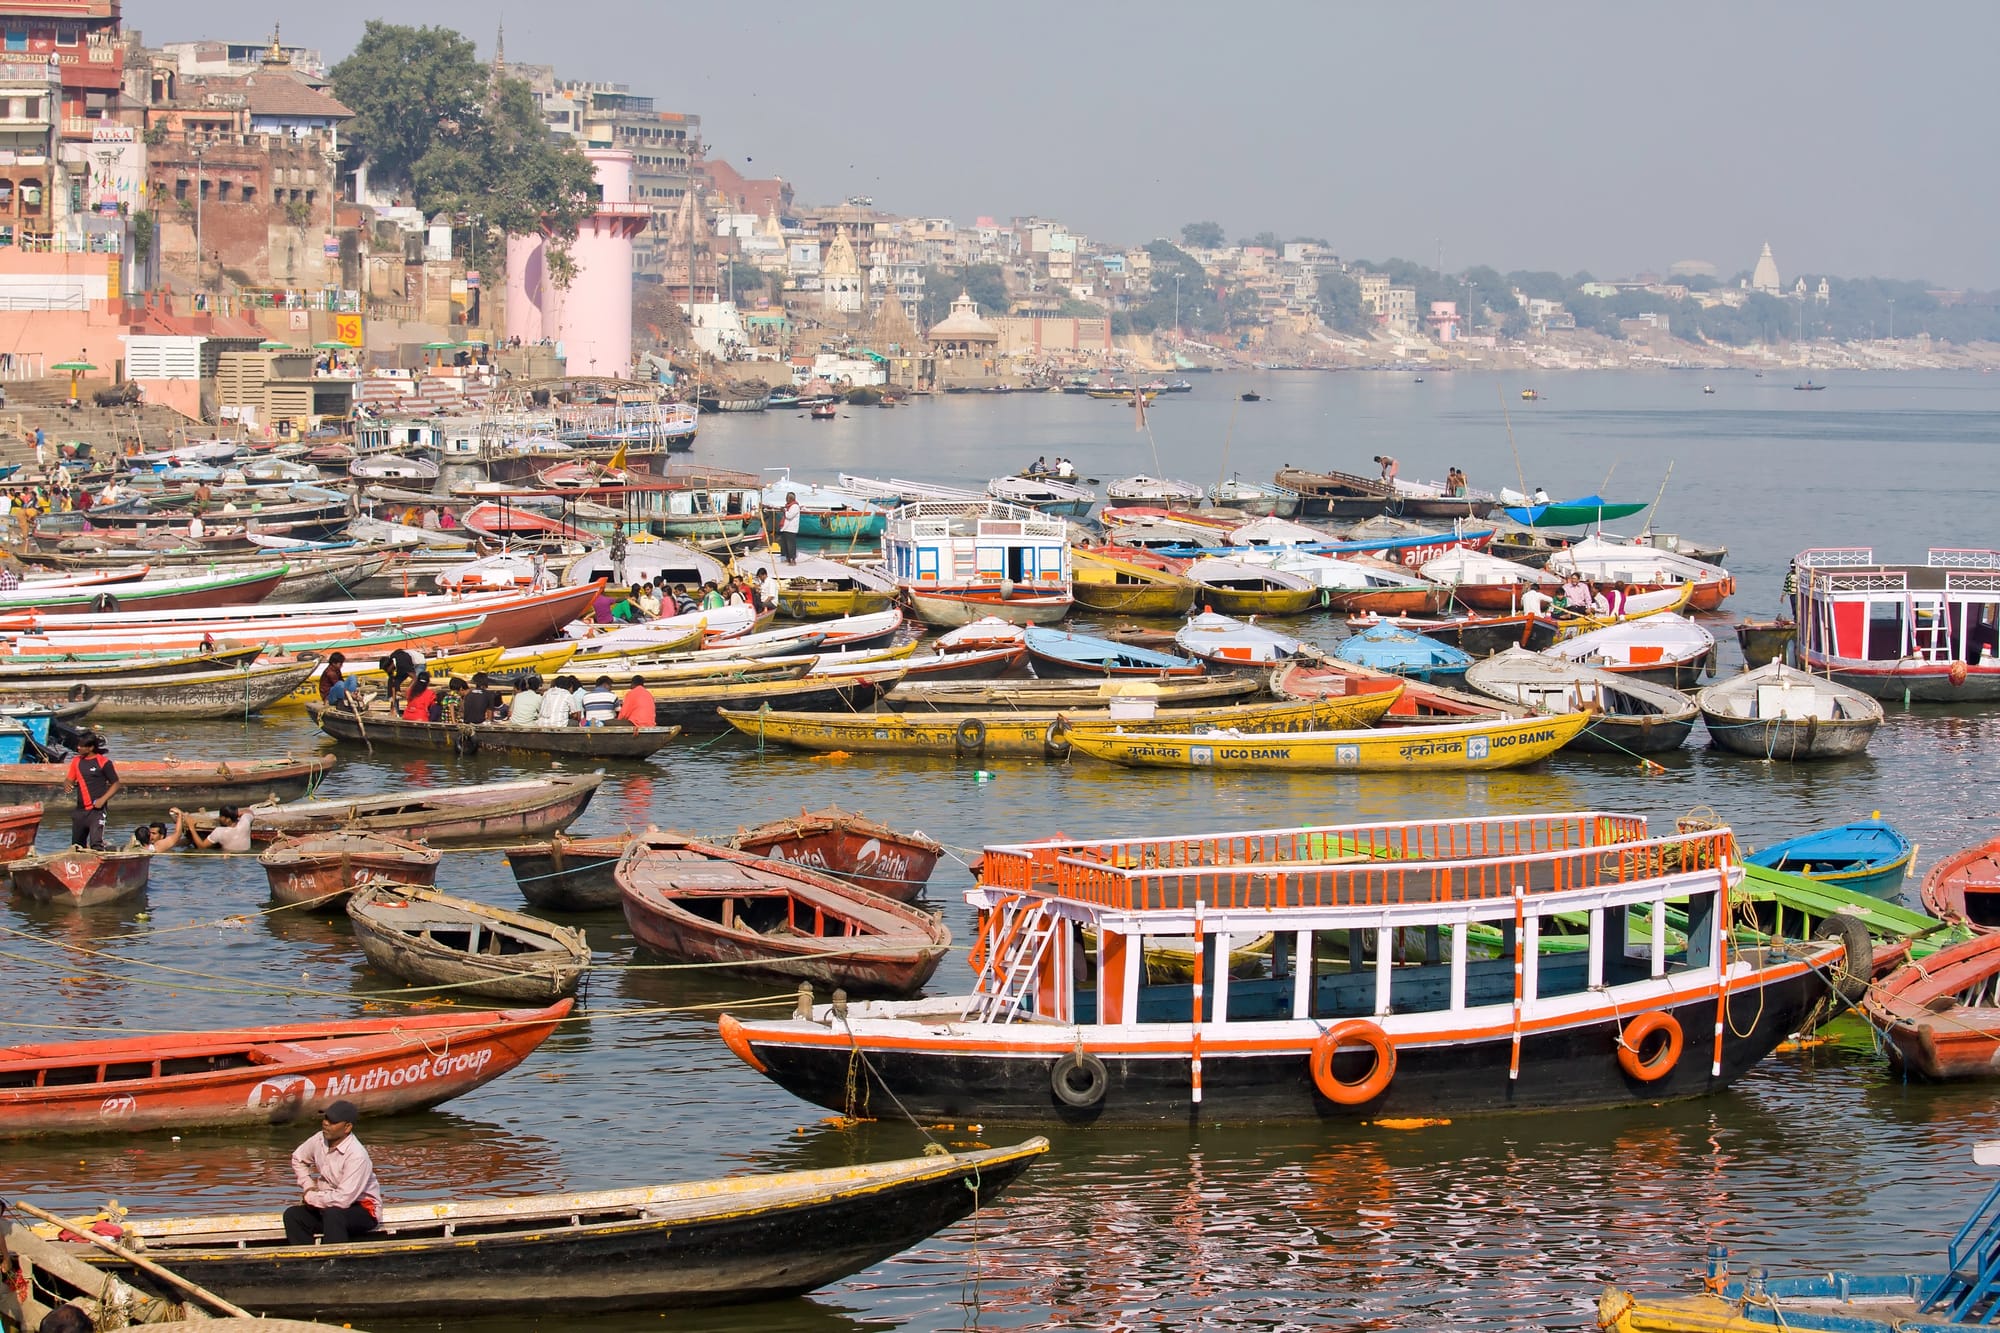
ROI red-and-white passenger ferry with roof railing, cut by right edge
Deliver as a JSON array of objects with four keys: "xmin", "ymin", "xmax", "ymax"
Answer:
[{"xmin": 1792, "ymin": 546, "xmax": 2000, "ymax": 703}]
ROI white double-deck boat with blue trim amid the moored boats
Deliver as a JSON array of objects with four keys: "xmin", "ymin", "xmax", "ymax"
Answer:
[{"xmin": 882, "ymin": 500, "xmax": 1074, "ymax": 626}]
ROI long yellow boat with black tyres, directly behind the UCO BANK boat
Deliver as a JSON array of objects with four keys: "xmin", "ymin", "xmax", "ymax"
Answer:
[{"xmin": 720, "ymin": 691, "xmax": 1400, "ymax": 759}]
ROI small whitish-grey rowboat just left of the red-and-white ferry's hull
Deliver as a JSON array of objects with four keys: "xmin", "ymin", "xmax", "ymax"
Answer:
[{"xmin": 1696, "ymin": 662, "xmax": 1882, "ymax": 761}]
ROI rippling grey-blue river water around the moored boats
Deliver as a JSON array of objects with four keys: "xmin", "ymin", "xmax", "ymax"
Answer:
[{"xmin": 0, "ymin": 370, "xmax": 2000, "ymax": 1333}]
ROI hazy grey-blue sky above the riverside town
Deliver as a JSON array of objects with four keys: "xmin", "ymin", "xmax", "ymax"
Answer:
[{"xmin": 156, "ymin": 0, "xmax": 2000, "ymax": 288}]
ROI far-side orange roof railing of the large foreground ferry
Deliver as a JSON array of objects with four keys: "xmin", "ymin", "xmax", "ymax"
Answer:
[{"xmin": 980, "ymin": 811, "xmax": 1646, "ymax": 889}]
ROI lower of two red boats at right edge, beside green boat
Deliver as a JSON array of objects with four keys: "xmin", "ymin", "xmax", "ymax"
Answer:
[{"xmin": 1860, "ymin": 935, "xmax": 2000, "ymax": 1079}]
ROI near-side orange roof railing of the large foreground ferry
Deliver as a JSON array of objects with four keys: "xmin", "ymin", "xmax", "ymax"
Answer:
[{"xmin": 1036, "ymin": 829, "xmax": 1736, "ymax": 911}]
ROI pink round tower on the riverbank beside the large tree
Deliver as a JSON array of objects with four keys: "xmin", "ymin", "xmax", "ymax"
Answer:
[{"xmin": 506, "ymin": 148, "xmax": 652, "ymax": 376}]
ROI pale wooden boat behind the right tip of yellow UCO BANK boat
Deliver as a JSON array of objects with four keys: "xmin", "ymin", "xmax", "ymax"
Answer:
[{"xmin": 1466, "ymin": 648, "xmax": 1700, "ymax": 755}]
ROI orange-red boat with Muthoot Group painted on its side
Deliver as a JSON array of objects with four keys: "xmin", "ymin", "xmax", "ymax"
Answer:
[{"xmin": 0, "ymin": 1001, "xmax": 572, "ymax": 1139}]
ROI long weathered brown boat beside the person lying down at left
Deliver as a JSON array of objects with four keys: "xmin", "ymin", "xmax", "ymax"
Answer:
[{"xmin": 190, "ymin": 773, "xmax": 604, "ymax": 847}]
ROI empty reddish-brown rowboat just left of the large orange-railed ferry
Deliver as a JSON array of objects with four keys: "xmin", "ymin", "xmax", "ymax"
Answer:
[{"xmin": 616, "ymin": 829, "xmax": 952, "ymax": 995}]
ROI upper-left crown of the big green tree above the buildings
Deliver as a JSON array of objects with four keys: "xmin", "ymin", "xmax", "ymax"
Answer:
[{"xmin": 332, "ymin": 18, "xmax": 486, "ymax": 182}]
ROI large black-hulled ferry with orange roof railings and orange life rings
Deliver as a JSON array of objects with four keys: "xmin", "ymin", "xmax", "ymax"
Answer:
[{"xmin": 720, "ymin": 813, "xmax": 1840, "ymax": 1125}]
